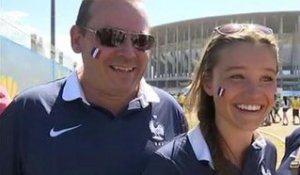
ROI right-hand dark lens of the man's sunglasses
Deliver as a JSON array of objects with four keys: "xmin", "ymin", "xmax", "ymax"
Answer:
[{"xmin": 131, "ymin": 34, "xmax": 155, "ymax": 51}]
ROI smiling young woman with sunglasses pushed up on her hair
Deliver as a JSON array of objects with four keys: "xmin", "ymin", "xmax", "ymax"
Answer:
[{"xmin": 144, "ymin": 24, "xmax": 278, "ymax": 175}]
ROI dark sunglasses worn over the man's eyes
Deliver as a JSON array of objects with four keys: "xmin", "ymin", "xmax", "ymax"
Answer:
[{"xmin": 82, "ymin": 27, "xmax": 155, "ymax": 51}]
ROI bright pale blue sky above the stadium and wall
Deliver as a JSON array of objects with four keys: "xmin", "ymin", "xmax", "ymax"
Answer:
[{"xmin": 0, "ymin": 0, "xmax": 300, "ymax": 64}]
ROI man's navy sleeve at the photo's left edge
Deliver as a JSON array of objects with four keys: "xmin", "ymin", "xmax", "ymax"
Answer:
[{"xmin": 0, "ymin": 102, "xmax": 22, "ymax": 175}]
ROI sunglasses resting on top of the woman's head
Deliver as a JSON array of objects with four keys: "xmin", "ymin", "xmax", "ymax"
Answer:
[{"xmin": 213, "ymin": 23, "xmax": 273, "ymax": 35}]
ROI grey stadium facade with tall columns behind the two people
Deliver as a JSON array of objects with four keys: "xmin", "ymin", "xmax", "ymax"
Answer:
[{"xmin": 145, "ymin": 11, "xmax": 300, "ymax": 93}]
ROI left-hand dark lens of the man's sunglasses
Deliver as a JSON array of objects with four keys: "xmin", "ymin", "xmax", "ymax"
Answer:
[{"xmin": 97, "ymin": 28, "xmax": 126, "ymax": 47}]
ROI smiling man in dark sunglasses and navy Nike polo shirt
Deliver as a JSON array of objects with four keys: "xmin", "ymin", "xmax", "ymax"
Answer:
[{"xmin": 0, "ymin": 0, "xmax": 187, "ymax": 175}]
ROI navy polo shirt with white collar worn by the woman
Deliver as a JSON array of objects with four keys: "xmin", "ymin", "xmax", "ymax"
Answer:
[{"xmin": 143, "ymin": 127, "xmax": 276, "ymax": 175}]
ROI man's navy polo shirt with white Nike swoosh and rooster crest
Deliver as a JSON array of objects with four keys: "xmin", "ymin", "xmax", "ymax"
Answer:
[{"xmin": 0, "ymin": 72, "xmax": 187, "ymax": 175}]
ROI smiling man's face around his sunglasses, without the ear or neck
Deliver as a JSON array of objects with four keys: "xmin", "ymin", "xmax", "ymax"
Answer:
[{"xmin": 72, "ymin": 1, "xmax": 149, "ymax": 94}]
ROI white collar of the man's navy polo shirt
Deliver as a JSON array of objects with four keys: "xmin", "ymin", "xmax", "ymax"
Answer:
[{"xmin": 62, "ymin": 71, "xmax": 160, "ymax": 110}]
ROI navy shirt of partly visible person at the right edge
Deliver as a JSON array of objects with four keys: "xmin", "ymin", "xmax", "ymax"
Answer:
[{"xmin": 277, "ymin": 128, "xmax": 300, "ymax": 175}]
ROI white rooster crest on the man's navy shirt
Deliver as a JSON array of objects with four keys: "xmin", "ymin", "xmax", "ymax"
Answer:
[{"xmin": 149, "ymin": 115, "xmax": 165, "ymax": 146}]
